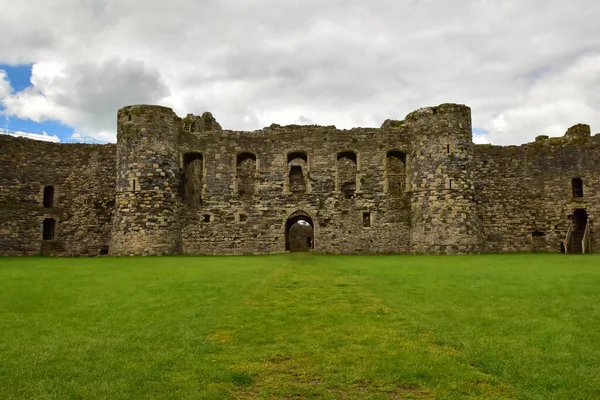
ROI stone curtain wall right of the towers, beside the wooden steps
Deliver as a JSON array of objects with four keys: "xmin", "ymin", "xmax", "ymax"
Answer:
[{"xmin": 474, "ymin": 125, "xmax": 600, "ymax": 253}]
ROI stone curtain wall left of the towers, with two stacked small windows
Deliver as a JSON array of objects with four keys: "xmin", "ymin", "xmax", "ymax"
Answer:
[{"xmin": 0, "ymin": 135, "xmax": 116, "ymax": 256}]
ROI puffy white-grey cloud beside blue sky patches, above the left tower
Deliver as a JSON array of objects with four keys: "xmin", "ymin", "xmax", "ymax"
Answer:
[{"xmin": 4, "ymin": 59, "xmax": 169, "ymax": 140}]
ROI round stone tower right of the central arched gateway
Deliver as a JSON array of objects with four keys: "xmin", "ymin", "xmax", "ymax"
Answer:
[{"xmin": 406, "ymin": 104, "xmax": 481, "ymax": 254}]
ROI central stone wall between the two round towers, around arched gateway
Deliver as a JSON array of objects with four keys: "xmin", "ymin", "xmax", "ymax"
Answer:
[{"xmin": 180, "ymin": 125, "xmax": 410, "ymax": 254}]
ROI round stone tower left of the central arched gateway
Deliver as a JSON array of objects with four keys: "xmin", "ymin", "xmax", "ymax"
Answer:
[{"xmin": 110, "ymin": 105, "xmax": 181, "ymax": 255}]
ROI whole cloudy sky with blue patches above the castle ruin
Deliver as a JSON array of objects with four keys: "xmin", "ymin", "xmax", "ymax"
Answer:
[{"xmin": 0, "ymin": 0, "xmax": 600, "ymax": 144}]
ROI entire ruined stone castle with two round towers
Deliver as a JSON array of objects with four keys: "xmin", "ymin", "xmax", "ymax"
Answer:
[{"xmin": 0, "ymin": 104, "xmax": 600, "ymax": 256}]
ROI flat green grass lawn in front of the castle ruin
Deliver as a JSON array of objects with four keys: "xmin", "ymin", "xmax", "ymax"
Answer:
[{"xmin": 0, "ymin": 254, "xmax": 600, "ymax": 400}]
